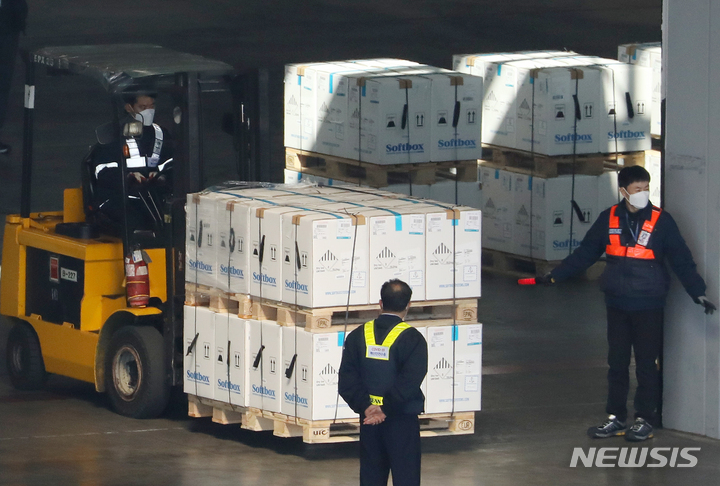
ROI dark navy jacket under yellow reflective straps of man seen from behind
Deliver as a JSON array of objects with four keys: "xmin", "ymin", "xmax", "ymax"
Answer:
[{"xmin": 338, "ymin": 314, "xmax": 427, "ymax": 416}]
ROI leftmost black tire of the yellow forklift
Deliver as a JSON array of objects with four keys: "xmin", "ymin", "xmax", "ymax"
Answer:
[{"xmin": 6, "ymin": 323, "xmax": 48, "ymax": 390}]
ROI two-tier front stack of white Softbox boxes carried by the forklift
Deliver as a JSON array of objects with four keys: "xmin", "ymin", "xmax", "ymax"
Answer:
[{"xmin": 185, "ymin": 184, "xmax": 482, "ymax": 420}]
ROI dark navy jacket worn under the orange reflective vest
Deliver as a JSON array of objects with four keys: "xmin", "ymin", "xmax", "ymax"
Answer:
[{"xmin": 551, "ymin": 201, "xmax": 705, "ymax": 310}]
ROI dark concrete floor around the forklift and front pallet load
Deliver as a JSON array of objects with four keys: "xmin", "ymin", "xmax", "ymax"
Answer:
[{"xmin": 0, "ymin": 274, "xmax": 720, "ymax": 486}]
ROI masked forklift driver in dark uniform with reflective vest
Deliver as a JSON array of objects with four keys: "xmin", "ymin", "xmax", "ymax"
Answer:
[{"xmin": 85, "ymin": 93, "xmax": 173, "ymax": 236}]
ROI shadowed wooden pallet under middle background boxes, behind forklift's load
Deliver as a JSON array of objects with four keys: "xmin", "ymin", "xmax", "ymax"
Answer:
[{"xmin": 285, "ymin": 148, "xmax": 477, "ymax": 188}]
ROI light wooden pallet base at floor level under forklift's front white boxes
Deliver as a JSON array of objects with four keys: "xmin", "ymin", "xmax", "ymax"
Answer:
[{"xmin": 188, "ymin": 395, "xmax": 475, "ymax": 444}]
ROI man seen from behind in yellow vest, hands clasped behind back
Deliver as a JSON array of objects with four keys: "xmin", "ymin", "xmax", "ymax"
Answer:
[{"xmin": 338, "ymin": 280, "xmax": 427, "ymax": 486}]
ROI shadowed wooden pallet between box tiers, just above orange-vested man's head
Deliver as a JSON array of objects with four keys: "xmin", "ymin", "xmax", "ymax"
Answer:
[{"xmin": 483, "ymin": 144, "xmax": 645, "ymax": 178}]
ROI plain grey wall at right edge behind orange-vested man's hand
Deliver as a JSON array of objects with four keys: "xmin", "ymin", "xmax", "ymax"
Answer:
[{"xmin": 663, "ymin": 0, "xmax": 720, "ymax": 438}]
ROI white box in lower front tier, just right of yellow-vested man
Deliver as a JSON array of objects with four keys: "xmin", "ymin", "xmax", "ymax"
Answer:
[{"xmin": 425, "ymin": 324, "xmax": 482, "ymax": 413}]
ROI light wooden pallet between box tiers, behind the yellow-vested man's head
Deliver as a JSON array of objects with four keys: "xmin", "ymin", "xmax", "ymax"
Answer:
[{"xmin": 252, "ymin": 299, "xmax": 478, "ymax": 332}]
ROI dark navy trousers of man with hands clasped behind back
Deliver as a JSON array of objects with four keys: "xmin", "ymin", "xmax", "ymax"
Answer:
[{"xmin": 360, "ymin": 415, "xmax": 420, "ymax": 486}]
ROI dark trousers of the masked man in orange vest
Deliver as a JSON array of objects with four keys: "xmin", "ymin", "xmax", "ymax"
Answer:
[{"xmin": 606, "ymin": 307, "xmax": 663, "ymax": 422}]
